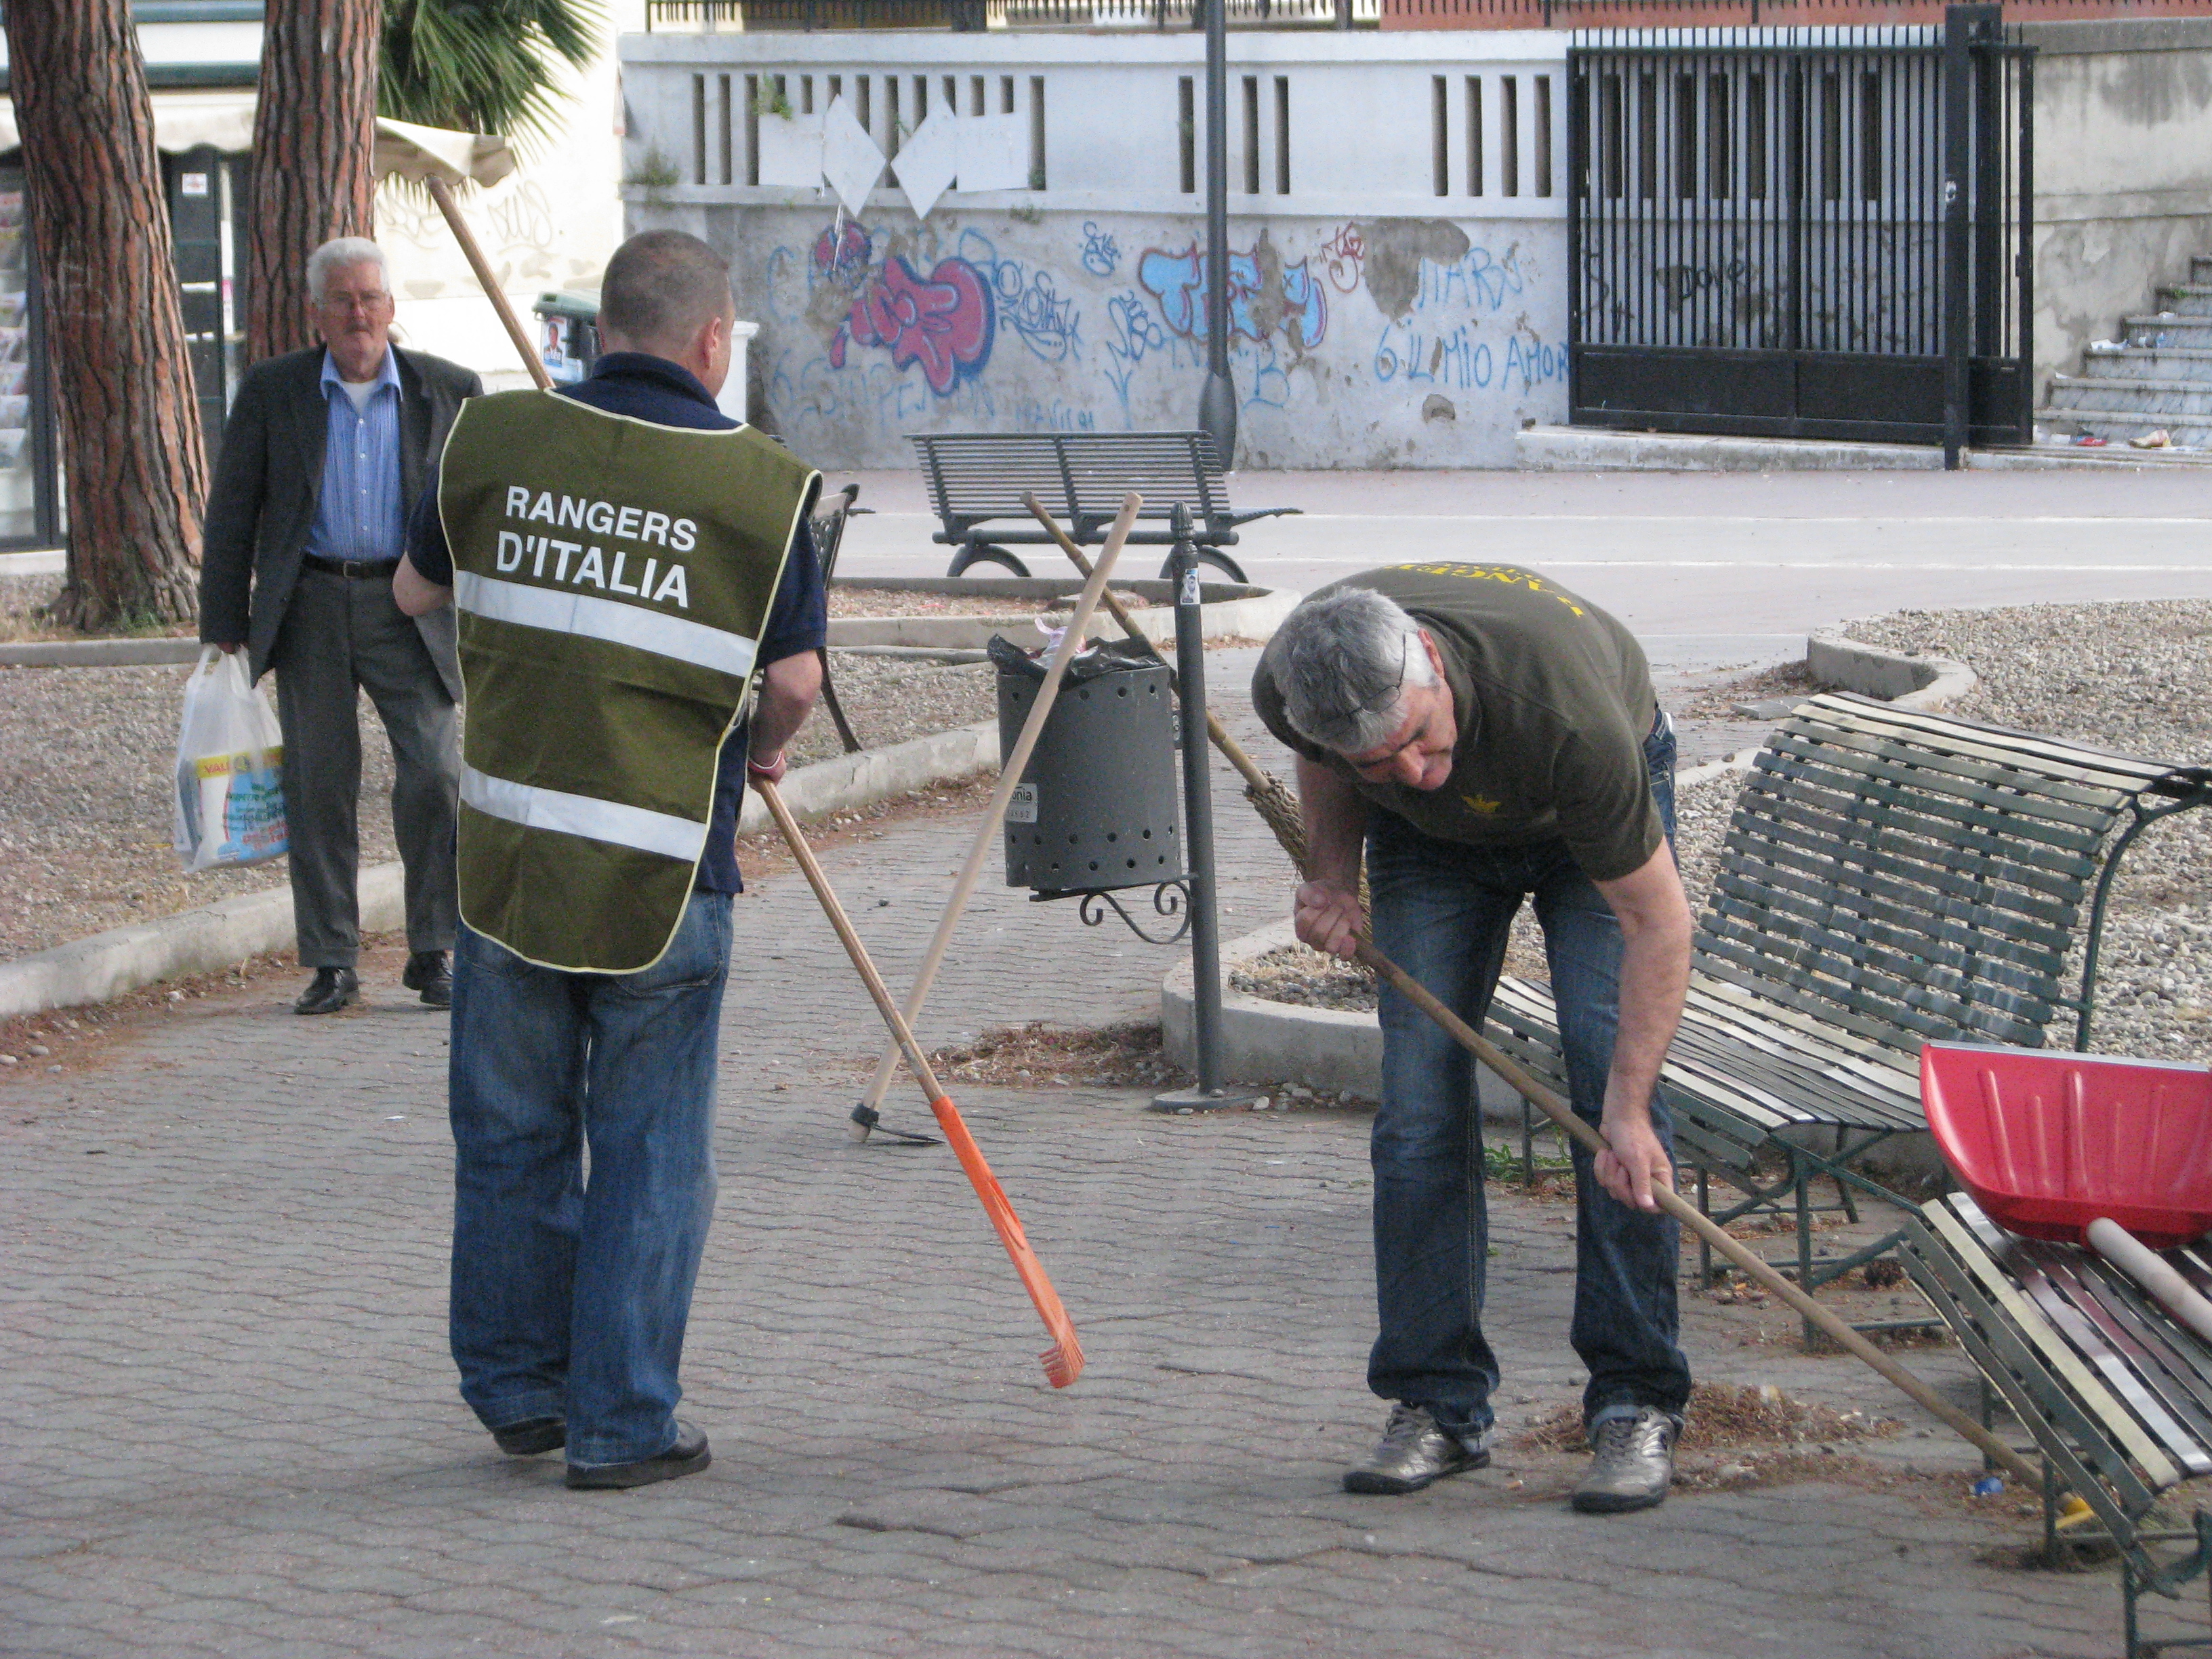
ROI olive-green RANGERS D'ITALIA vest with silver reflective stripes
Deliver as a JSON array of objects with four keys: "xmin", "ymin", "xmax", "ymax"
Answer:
[{"xmin": 438, "ymin": 392, "xmax": 821, "ymax": 973}]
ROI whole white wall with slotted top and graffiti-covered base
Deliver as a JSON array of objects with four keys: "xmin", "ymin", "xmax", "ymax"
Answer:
[{"xmin": 621, "ymin": 35, "xmax": 1566, "ymax": 467}]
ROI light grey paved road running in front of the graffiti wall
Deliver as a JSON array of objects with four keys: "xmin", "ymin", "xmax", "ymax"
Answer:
[{"xmin": 840, "ymin": 467, "xmax": 2212, "ymax": 668}]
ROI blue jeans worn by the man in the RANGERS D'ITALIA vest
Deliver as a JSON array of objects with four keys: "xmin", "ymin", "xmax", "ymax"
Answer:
[{"xmin": 451, "ymin": 894, "xmax": 730, "ymax": 1465}]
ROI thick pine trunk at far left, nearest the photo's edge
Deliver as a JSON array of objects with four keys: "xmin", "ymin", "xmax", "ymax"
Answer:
[{"xmin": 7, "ymin": 0, "xmax": 208, "ymax": 628}]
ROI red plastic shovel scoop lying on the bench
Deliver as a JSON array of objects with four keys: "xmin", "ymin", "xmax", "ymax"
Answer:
[{"xmin": 1920, "ymin": 1042, "xmax": 2212, "ymax": 1250}]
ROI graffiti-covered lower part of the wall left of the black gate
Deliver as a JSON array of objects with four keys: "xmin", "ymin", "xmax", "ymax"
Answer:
[{"xmin": 754, "ymin": 215, "xmax": 1566, "ymax": 464}]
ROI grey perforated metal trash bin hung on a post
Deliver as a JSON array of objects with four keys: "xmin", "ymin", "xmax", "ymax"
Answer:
[{"xmin": 991, "ymin": 637, "xmax": 1186, "ymax": 914}]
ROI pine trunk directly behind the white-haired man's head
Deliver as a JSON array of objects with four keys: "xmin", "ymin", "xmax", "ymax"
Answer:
[{"xmin": 245, "ymin": 0, "xmax": 383, "ymax": 363}]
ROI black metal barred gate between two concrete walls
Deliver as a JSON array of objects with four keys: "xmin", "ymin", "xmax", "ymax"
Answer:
[{"xmin": 1566, "ymin": 5, "xmax": 2035, "ymax": 462}]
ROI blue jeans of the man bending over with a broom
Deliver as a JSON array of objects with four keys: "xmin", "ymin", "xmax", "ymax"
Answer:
[{"xmin": 1367, "ymin": 719, "xmax": 1690, "ymax": 1440}]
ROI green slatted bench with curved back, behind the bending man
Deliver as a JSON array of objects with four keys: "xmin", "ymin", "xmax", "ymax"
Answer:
[{"xmin": 1489, "ymin": 695, "xmax": 2212, "ymax": 1323}]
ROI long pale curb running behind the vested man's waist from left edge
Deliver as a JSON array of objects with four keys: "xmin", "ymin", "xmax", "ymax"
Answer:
[{"xmin": 0, "ymin": 721, "xmax": 998, "ymax": 1020}]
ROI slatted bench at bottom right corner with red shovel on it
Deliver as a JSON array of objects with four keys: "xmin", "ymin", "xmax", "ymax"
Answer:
[{"xmin": 1898, "ymin": 1192, "xmax": 2212, "ymax": 1659}]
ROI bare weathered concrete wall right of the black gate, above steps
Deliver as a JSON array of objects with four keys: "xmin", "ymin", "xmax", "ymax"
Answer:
[{"xmin": 2022, "ymin": 18, "xmax": 2212, "ymax": 387}]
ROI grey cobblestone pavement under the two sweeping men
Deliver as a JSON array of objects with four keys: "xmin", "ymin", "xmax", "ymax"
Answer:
[{"xmin": 0, "ymin": 676, "xmax": 2117, "ymax": 1659}]
